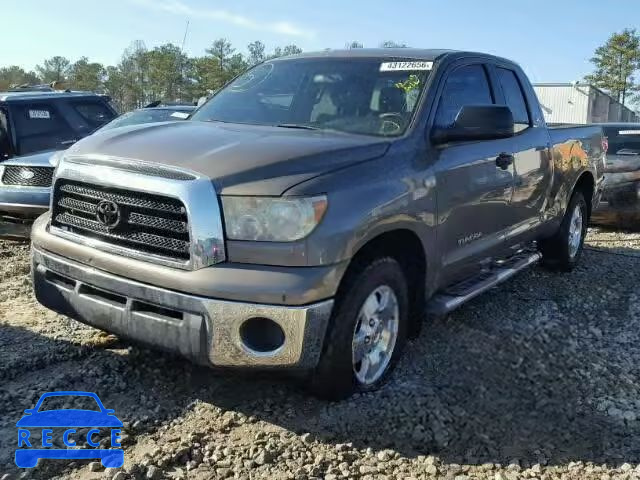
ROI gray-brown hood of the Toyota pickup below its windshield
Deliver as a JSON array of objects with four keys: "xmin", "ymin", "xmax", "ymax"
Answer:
[{"xmin": 68, "ymin": 121, "xmax": 389, "ymax": 195}]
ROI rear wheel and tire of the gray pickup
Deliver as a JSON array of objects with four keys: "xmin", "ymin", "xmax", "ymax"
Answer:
[{"xmin": 539, "ymin": 191, "xmax": 589, "ymax": 272}]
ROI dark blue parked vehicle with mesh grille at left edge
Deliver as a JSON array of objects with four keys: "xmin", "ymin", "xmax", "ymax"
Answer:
[{"xmin": 0, "ymin": 86, "xmax": 116, "ymax": 236}]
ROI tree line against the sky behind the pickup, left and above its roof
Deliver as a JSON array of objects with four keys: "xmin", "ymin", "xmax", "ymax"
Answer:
[{"xmin": 0, "ymin": 38, "xmax": 406, "ymax": 112}]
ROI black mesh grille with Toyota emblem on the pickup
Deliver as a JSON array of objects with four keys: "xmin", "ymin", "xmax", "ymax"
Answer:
[{"xmin": 51, "ymin": 179, "xmax": 190, "ymax": 261}]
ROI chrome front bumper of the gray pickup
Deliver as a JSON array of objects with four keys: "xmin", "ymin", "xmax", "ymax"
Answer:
[{"xmin": 32, "ymin": 246, "xmax": 333, "ymax": 368}]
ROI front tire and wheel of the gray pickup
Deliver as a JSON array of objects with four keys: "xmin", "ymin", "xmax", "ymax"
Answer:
[{"xmin": 307, "ymin": 257, "xmax": 409, "ymax": 400}]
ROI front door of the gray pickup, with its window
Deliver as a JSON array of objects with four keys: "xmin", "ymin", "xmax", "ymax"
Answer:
[{"xmin": 433, "ymin": 61, "xmax": 514, "ymax": 284}]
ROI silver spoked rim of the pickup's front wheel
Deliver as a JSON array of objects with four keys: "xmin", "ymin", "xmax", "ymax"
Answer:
[{"xmin": 351, "ymin": 285, "xmax": 400, "ymax": 385}]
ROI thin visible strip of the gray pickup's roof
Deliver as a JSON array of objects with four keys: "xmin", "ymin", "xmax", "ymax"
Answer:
[{"xmin": 274, "ymin": 48, "xmax": 514, "ymax": 63}]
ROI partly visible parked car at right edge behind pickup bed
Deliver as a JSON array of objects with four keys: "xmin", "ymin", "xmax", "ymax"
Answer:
[{"xmin": 594, "ymin": 123, "xmax": 640, "ymax": 229}]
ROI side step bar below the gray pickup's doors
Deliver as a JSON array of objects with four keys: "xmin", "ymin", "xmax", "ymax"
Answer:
[{"xmin": 427, "ymin": 252, "xmax": 542, "ymax": 316}]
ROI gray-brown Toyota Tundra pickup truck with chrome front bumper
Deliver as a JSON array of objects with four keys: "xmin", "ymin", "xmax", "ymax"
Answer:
[{"xmin": 32, "ymin": 49, "xmax": 604, "ymax": 399}]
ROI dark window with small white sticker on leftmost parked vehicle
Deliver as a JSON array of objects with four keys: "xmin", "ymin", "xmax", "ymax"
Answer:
[{"xmin": 11, "ymin": 103, "xmax": 75, "ymax": 155}]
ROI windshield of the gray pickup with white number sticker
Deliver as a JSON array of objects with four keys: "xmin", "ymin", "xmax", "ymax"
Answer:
[{"xmin": 192, "ymin": 58, "xmax": 432, "ymax": 136}]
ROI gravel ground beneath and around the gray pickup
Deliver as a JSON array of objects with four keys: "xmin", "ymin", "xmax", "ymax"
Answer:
[{"xmin": 0, "ymin": 230, "xmax": 640, "ymax": 480}]
